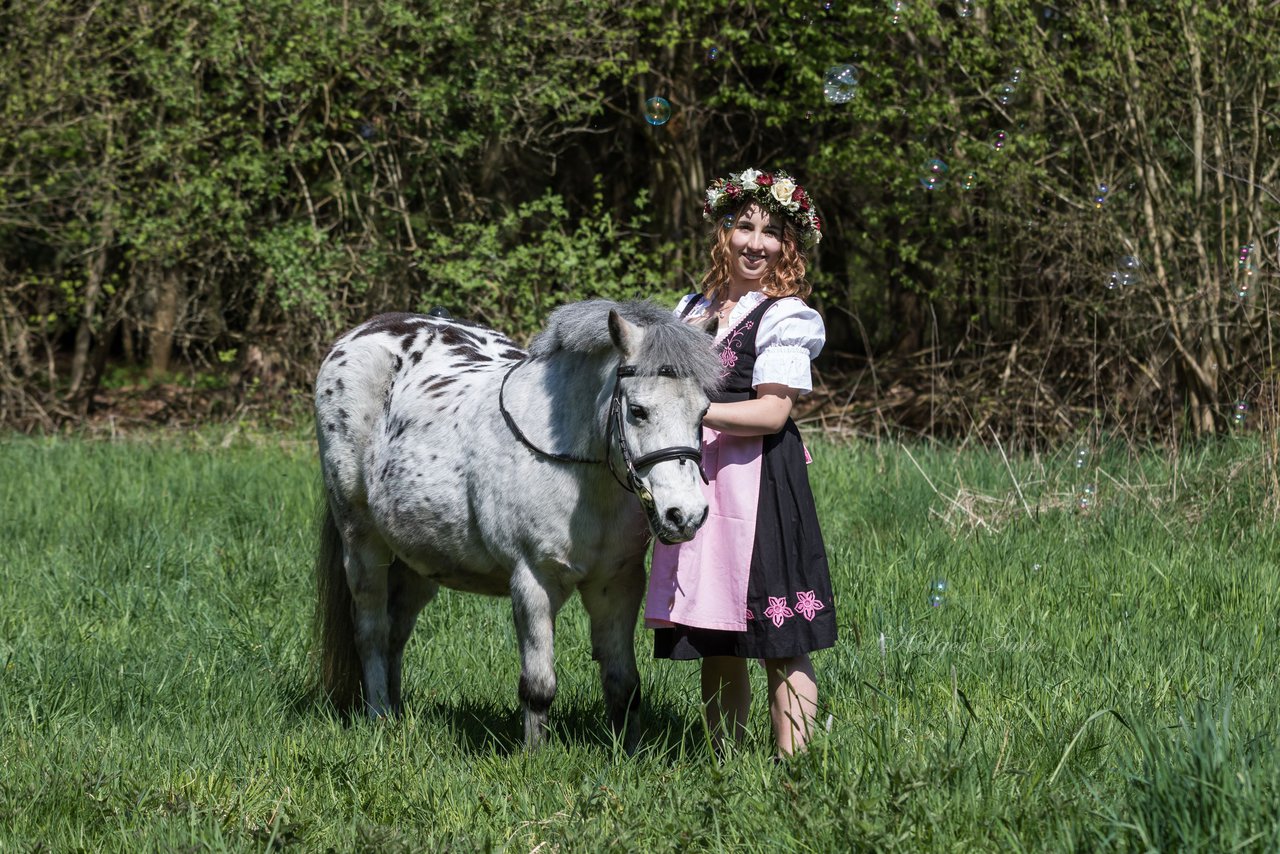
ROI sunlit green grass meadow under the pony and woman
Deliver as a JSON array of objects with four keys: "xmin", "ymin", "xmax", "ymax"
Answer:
[{"xmin": 0, "ymin": 434, "xmax": 1280, "ymax": 851}]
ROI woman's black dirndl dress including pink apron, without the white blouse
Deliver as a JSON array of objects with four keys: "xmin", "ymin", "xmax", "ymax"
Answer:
[{"xmin": 645, "ymin": 294, "xmax": 836, "ymax": 661}]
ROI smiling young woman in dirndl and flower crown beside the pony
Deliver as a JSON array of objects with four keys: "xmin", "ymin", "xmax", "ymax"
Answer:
[{"xmin": 645, "ymin": 169, "xmax": 836, "ymax": 755}]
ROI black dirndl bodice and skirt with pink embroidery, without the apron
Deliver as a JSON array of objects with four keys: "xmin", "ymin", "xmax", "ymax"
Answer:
[{"xmin": 654, "ymin": 298, "xmax": 836, "ymax": 659}]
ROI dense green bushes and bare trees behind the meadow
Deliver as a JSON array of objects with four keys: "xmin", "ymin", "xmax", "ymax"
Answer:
[{"xmin": 0, "ymin": 0, "xmax": 1280, "ymax": 446}]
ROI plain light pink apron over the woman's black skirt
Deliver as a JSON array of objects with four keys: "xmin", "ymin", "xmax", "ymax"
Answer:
[{"xmin": 644, "ymin": 426, "xmax": 763, "ymax": 631}]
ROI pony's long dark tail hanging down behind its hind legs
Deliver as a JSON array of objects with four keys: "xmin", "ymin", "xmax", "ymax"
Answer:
[{"xmin": 314, "ymin": 497, "xmax": 361, "ymax": 714}]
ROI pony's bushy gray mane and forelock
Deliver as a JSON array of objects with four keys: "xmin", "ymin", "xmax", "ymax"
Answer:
[{"xmin": 529, "ymin": 300, "xmax": 721, "ymax": 393}]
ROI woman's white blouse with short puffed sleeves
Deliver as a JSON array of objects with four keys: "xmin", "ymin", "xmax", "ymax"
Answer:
[{"xmin": 676, "ymin": 291, "xmax": 827, "ymax": 392}]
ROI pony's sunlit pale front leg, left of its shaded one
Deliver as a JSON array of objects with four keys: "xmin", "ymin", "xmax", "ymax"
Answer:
[{"xmin": 511, "ymin": 566, "xmax": 564, "ymax": 748}]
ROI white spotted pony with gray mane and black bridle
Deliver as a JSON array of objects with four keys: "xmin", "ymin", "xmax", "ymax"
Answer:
[{"xmin": 315, "ymin": 300, "xmax": 721, "ymax": 749}]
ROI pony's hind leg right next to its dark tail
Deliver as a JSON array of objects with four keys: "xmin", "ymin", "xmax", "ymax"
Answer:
[{"xmin": 343, "ymin": 535, "xmax": 392, "ymax": 718}]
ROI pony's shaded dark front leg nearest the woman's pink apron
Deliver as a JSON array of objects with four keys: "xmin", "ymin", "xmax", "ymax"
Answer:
[{"xmin": 579, "ymin": 566, "xmax": 645, "ymax": 752}]
